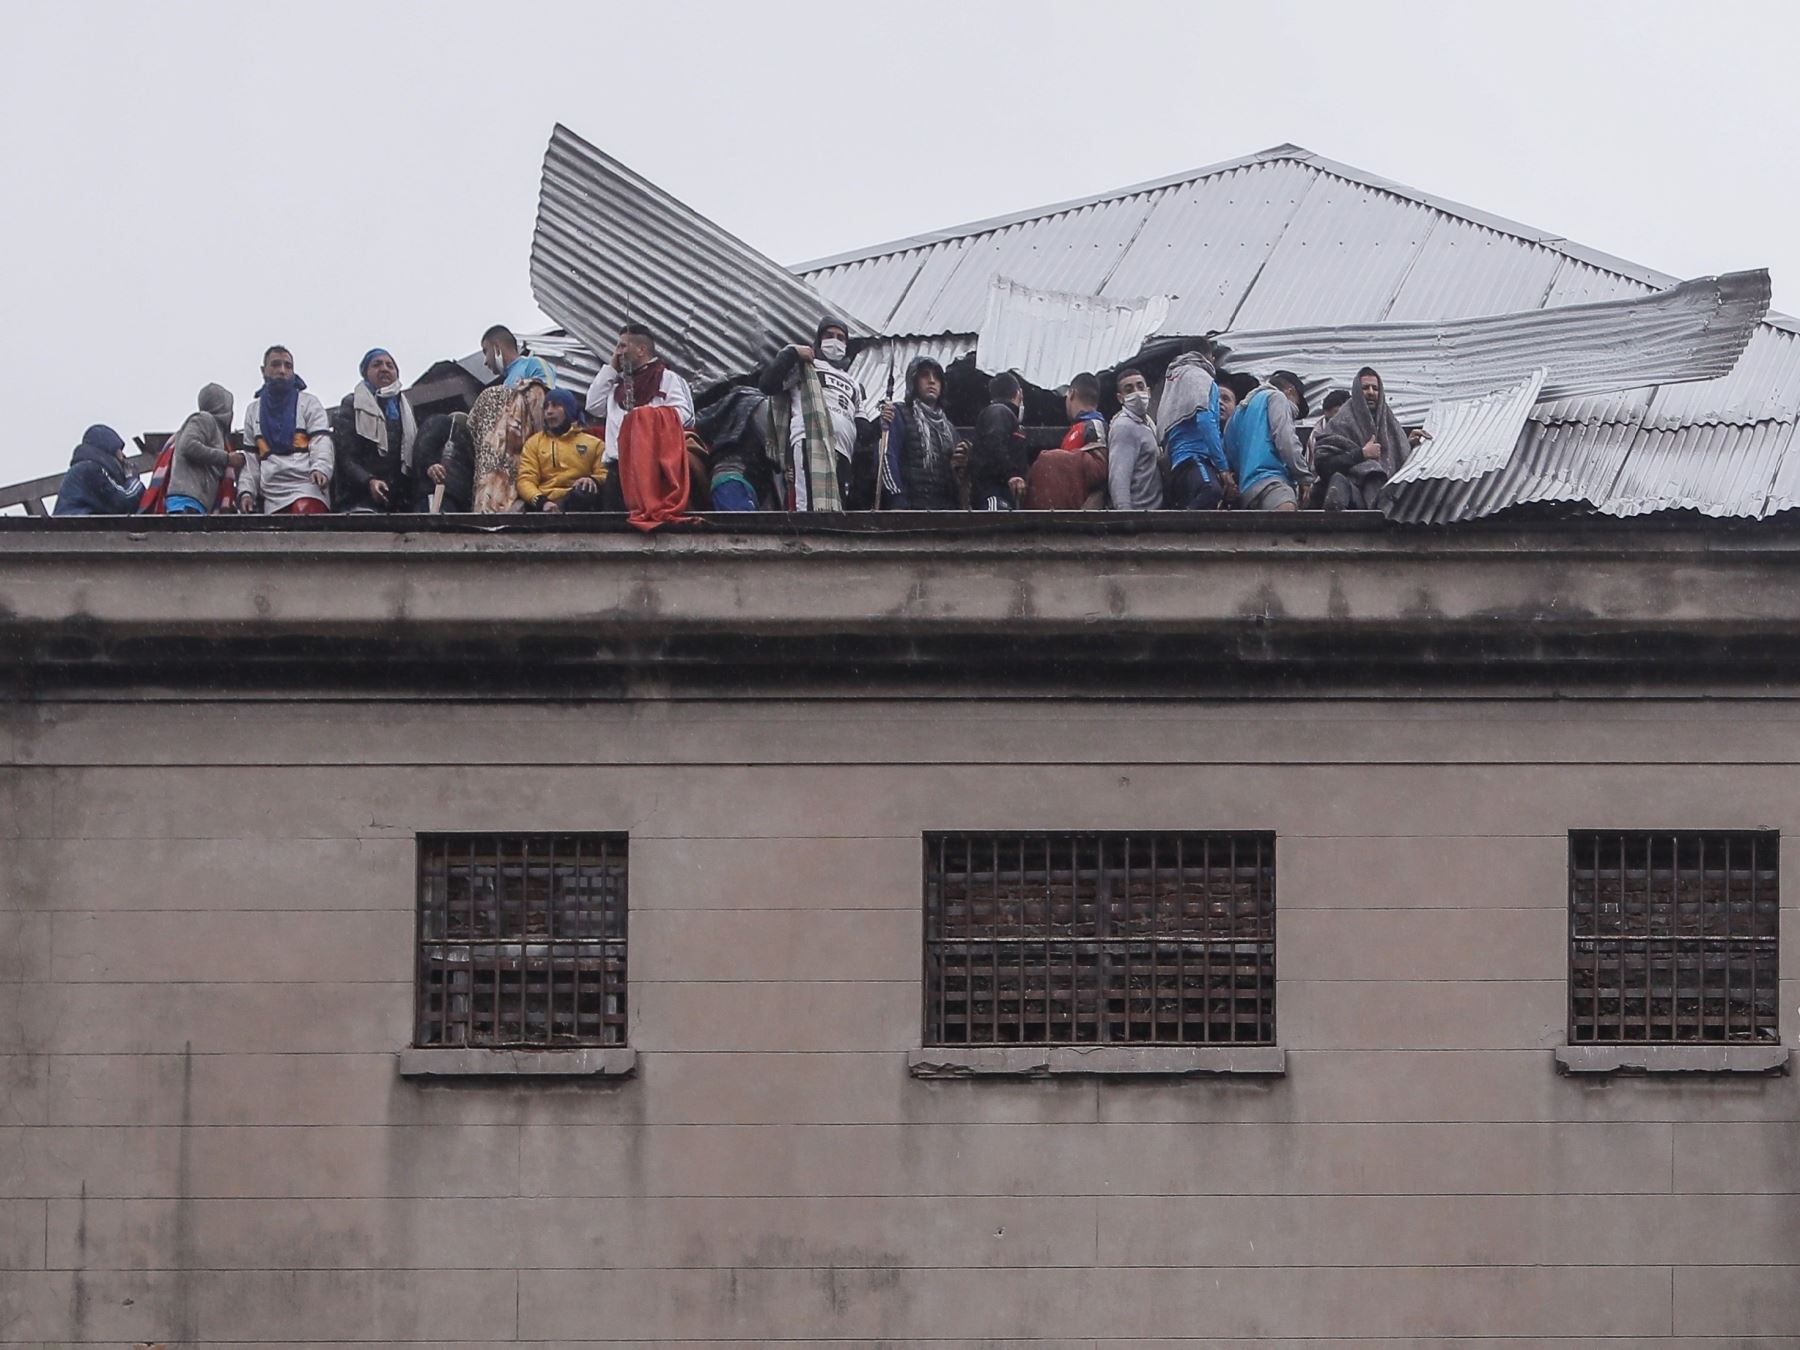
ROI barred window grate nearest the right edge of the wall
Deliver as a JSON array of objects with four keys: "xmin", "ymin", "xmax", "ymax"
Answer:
[{"xmin": 1570, "ymin": 830, "xmax": 1780, "ymax": 1044}]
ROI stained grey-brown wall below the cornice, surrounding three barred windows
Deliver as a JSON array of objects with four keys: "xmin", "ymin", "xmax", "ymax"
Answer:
[{"xmin": 0, "ymin": 698, "xmax": 1800, "ymax": 1350}]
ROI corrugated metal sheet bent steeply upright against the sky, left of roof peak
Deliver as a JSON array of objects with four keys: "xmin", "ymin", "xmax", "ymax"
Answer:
[{"xmin": 531, "ymin": 126, "xmax": 871, "ymax": 385}]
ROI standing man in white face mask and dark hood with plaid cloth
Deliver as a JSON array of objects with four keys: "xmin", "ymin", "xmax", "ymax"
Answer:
[{"xmin": 756, "ymin": 317, "xmax": 878, "ymax": 511}]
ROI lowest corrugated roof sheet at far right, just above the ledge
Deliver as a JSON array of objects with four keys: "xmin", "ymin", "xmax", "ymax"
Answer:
[{"xmin": 1597, "ymin": 421, "xmax": 1795, "ymax": 518}]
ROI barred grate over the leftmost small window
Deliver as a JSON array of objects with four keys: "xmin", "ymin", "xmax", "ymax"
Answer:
[{"xmin": 416, "ymin": 835, "xmax": 626, "ymax": 1049}]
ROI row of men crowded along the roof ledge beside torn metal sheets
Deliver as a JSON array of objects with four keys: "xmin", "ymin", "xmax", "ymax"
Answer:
[{"xmin": 56, "ymin": 317, "xmax": 1422, "ymax": 527}]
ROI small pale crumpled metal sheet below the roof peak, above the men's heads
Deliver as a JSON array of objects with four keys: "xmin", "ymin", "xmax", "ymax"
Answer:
[{"xmin": 976, "ymin": 277, "xmax": 1168, "ymax": 389}]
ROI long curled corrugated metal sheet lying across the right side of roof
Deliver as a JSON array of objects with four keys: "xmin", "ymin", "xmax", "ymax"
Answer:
[{"xmin": 1220, "ymin": 272, "xmax": 1769, "ymax": 418}]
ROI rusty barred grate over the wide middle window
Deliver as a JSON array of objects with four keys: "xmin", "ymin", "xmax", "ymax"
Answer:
[{"xmin": 925, "ymin": 833, "xmax": 1274, "ymax": 1046}]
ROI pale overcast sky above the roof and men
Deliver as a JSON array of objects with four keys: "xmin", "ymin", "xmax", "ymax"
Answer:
[{"xmin": 0, "ymin": 0, "xmax": 1800, "ymax": 484}]
